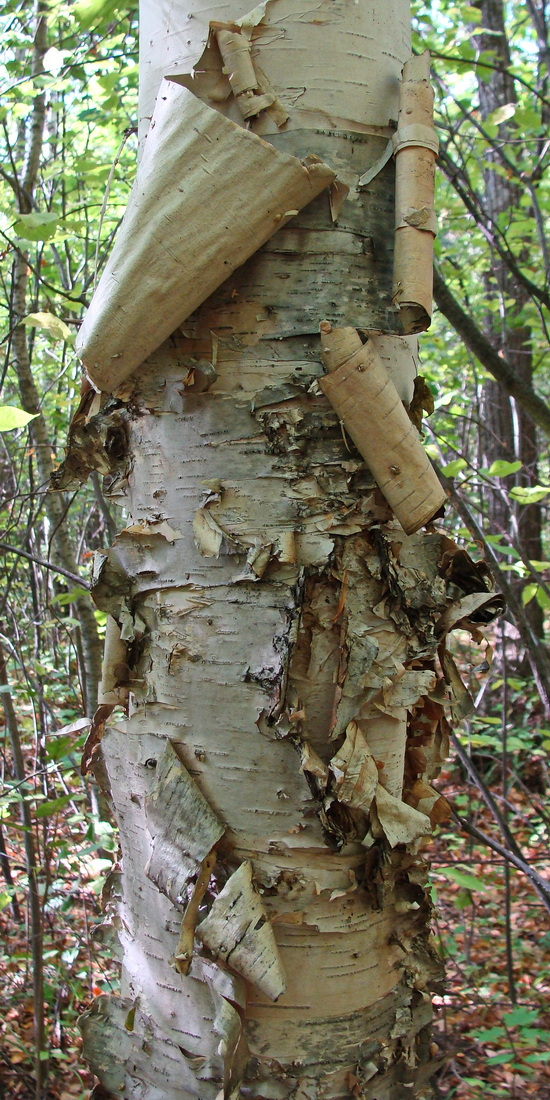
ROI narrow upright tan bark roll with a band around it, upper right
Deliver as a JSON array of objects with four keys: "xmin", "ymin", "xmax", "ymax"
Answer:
[{"xmin": 394, "ymin": 52, "xmax": 439, "ymax": 333}]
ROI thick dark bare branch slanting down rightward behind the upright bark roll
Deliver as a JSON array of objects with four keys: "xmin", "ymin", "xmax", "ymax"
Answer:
[{"xmin": 433, "ymin": 271, "xmax": 550, "ymax": 439}]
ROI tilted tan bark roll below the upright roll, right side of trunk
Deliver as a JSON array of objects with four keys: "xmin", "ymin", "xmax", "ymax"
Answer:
[{"xmin": 320, "ymin": 321, "xmax": 447, "ymax": 535}]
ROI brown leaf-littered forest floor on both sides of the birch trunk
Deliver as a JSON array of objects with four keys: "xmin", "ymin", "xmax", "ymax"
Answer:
[{"xmin": 0, "ymin": 770, "xmax": 550, "ymax": 1100}]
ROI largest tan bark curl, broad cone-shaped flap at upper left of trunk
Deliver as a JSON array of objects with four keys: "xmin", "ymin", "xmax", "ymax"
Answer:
[{"xmin": 77, "ymin": 80, "xmax": 336, "ymax": 391}]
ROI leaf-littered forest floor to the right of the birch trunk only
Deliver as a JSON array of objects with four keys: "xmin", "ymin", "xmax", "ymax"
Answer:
[{"xmin": 430, "ymin": 774, "xmax": 550, "ymax": 1100}]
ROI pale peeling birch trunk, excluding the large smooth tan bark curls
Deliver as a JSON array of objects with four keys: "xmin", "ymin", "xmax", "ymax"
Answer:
[{"xmin": 77, "ymin": 0, "xmax": 503, "ymax": 1100}]
